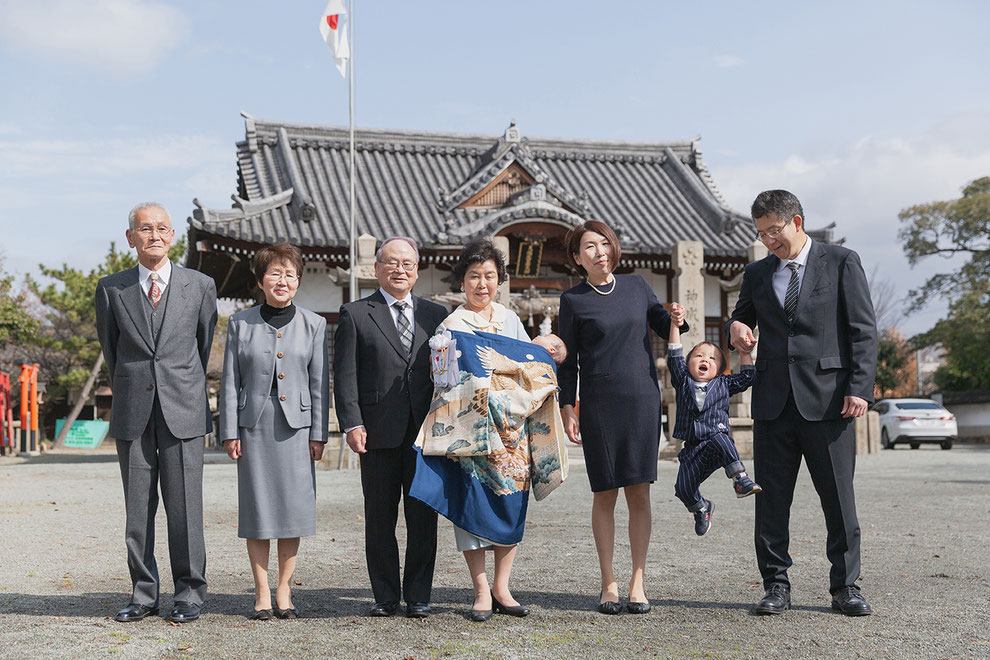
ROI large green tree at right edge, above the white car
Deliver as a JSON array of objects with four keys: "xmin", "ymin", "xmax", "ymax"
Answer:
[{"xmin": 898, "ymin": 177, "xmax": 990, "ymax": 391}]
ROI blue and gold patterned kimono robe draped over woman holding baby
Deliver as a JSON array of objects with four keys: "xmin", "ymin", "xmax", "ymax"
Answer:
[{"xmin": 409, "ymin": 330, "xmax": 567, "ymax": 545}]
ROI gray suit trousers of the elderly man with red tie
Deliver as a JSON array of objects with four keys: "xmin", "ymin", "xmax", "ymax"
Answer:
[{"xmin": 117, "ymin": 397, "xmax": 206, "ymax": 607}]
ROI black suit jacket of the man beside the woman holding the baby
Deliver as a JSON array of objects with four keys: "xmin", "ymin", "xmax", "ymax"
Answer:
[{"xmin": 333, "ymin": 291, "xmax": 447, "ymax": 449}]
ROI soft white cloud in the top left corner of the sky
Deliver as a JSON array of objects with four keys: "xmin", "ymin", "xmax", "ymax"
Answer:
[{"xmin": 0, "ymin": 0, "xmax": 188, "ymax": 75}]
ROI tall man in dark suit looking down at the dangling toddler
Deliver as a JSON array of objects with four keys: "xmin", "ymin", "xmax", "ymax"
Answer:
[{"xmin": 728, "ymin": 190, "xmax": 877, "ymax": 616}]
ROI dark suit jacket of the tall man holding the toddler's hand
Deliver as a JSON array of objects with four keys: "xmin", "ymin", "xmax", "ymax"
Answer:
[{"xmin": 726, "ymin": 241, "xmax": 877, "ymax": 421}]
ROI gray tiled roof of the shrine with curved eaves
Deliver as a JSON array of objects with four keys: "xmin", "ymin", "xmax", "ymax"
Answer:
[{"xmin": 189, "ymin": 115, "xmax": 753, "ymax": 257}]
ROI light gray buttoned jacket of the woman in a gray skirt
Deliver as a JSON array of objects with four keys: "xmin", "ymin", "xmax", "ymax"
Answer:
[{"xmin": 220, "ymin": 305, "xmax": 330, "ymax": 442}]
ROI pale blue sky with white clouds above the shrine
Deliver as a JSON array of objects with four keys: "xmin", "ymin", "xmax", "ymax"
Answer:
[{"xmin": 0, "ymin": 0, "xmax": 990, "ymax": 334}]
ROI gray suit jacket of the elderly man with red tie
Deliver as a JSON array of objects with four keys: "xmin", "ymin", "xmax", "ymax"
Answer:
[{"xmin": 96, "ymin": 264, "xmax": 217, "ymax": 440}]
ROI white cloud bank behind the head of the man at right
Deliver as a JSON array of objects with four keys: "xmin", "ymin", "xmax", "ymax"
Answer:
[{"xmin": 714, "ymin": 114, "xmax": 990, "ymax": 332}]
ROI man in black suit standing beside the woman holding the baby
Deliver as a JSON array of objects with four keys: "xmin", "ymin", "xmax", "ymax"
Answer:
[{"xmin": 333, "ymin": 237, "xmax": 447, "ymax": 618}]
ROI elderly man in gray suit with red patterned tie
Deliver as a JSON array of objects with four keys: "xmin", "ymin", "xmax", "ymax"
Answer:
[{"xmin": 96, "ymin": 203, "xmax": 217, "ymax": 622}]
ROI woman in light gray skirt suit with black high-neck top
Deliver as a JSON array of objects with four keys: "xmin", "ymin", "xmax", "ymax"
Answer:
[{"xmin": 220, "ymin": 243, "xmax": 330, "ymax": 620}]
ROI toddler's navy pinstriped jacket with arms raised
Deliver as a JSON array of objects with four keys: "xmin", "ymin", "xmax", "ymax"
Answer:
[{"xmin": 667, "ymin": 348, "xmax": 756, "ymax": 440}]
